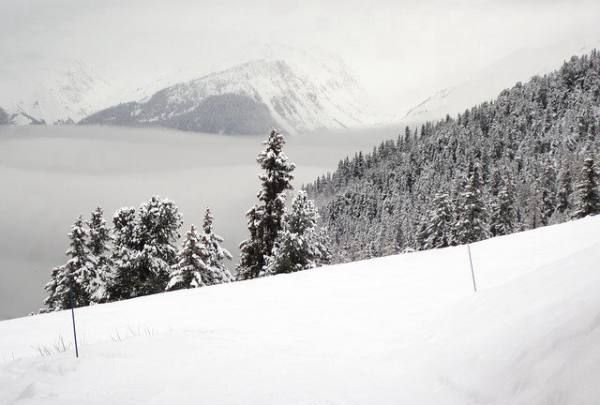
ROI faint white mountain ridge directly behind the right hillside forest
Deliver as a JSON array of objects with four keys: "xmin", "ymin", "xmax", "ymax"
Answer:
[{"xmin": 401, "ymin": 41, "xmax": 600, "ymax": 122}]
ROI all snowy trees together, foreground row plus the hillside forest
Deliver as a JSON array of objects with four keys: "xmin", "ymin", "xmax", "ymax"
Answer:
[{"xmin": 44, "ymin": 51, "xmax": 600, "ymax": 311}]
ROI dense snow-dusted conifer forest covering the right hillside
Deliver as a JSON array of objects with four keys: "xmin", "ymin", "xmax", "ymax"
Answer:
[{"xmin": 305, "ymin": 51, "xmax": 600, "ymax": 262}]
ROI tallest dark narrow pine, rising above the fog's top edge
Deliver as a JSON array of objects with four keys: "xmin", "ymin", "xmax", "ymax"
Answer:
[{"xmin": 238, "ymin": 130, "xmax": 295, "ymax": 279}]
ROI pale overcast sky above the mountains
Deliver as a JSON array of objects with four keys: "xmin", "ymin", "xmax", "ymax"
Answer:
[{"xmin": 0, "ymin": 0, "xmax": 600, "ymax": 114}]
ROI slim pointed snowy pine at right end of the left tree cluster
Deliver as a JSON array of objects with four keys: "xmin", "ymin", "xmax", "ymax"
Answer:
[{"xmin": 201, "ymin": 209, "xmax": 233, "ymax": 285}]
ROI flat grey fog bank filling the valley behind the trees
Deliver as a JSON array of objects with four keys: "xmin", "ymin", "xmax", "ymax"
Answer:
[{"xmin": 0, "ymin": 126, "xmax": 398, "ymax": 319}]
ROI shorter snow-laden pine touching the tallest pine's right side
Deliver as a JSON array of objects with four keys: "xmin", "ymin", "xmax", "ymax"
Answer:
[{"xmin": 265, "ymin": 191, "xmax": 331, "ymax": 274}]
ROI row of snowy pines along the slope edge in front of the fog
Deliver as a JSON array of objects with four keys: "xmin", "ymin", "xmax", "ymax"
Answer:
[{"xmin": 41, "ymin": 131, "xmax": 330, "ymax": 312}]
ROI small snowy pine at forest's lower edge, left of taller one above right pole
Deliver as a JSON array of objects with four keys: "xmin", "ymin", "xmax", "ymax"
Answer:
[{"xmin": 423, "ymin": 193, "xmax": 454, "ymax": 249}]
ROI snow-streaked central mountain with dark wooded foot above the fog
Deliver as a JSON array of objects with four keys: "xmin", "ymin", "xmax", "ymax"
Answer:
[{"xmin": 80, "ymin": 59, "xmax": 366, "ymax": 134}]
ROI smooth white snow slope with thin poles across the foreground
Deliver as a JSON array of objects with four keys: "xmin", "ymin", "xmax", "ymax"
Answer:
[{"xmin": 0, "ymin": 217, "xmax": 600, "ymax": 405}]
